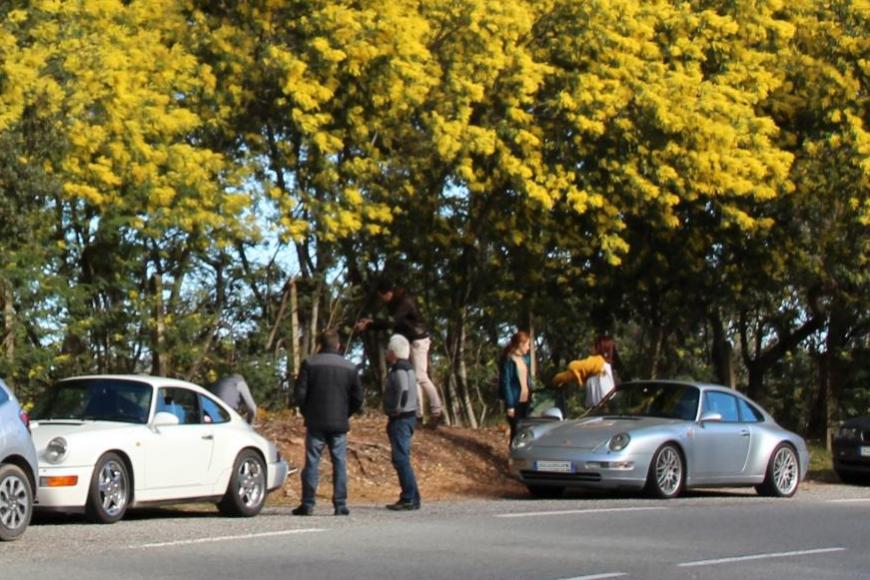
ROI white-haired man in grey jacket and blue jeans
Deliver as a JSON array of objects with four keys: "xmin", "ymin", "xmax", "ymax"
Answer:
[{"xmin": 384, "ymin": 334, "xmax": 420, "ymax": 511}]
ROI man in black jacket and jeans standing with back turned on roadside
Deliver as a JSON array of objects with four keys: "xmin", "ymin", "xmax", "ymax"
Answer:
[{"xmin": 293, "ymin": 331, "xmax": 364, "ymax": 516}]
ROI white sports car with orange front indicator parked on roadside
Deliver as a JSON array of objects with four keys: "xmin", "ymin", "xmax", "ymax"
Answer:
[{"xmin": 31, "ymin": 375, "xmax": 288, "ymax": 523}]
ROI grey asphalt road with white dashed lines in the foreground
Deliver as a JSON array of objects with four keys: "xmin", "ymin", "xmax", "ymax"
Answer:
[{"xmin": 0, "ymin": 484, "xmax": 870, "ymax": 580}]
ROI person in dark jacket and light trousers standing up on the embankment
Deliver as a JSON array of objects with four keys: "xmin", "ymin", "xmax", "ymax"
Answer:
[{"xmin": 356, "ymin": 280, "xmax": 444, "ymax": 427}]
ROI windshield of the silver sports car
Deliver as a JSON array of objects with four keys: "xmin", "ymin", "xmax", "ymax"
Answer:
[{"xmin": 586, "ymin": 383, "xmax": 700, "ymax": 421}]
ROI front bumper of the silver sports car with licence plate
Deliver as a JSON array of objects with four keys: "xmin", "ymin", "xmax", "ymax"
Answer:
[{"xmin": 510, "ymin": 448, "xmax": 650, "ymax": 489}]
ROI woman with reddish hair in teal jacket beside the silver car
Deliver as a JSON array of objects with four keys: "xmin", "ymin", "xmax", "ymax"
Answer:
[{"xmin": 499, "ymin": 330, "xmax": 532, "ymax": 441}]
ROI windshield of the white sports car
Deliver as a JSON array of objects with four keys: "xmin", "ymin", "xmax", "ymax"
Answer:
[{"xmin": 31, "ymin": 379, "xmax": 152, "ymax": 423}]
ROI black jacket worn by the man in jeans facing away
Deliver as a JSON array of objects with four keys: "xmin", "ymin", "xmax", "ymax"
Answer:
[{"xmin": 295, "ymin": 350, "xmax": 364, "ymax": 433}]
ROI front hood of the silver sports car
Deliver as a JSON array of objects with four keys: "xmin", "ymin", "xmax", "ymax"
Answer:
[{"xmin": 533, "ymin": 416, "xmax": 676, "ymax": 449}]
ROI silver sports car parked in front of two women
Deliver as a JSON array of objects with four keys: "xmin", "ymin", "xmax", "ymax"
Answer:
[{"xmin": 511, "ymin": 381, "xmax": 809, "ymax": 498}]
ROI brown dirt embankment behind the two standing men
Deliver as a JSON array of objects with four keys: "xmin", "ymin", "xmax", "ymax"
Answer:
[{"xmin": 257, "ymin": 413, "xmax": 525, "ymax": 505}]
